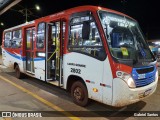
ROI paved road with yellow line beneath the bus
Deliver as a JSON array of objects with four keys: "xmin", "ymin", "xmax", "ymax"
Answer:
[{"xmin": 0, "ymin": 57, "xmax": 160, "ymax": 120}]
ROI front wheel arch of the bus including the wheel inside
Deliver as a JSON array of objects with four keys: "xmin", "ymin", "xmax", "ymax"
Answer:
[{"xmin": 67, "ymin": 75, "xmax": 89, "ymax": 106}]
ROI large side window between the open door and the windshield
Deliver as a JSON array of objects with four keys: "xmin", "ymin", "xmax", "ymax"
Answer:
[{"xmin": 68, "ymin": 12, "xmax": 106, "ymax": 60}]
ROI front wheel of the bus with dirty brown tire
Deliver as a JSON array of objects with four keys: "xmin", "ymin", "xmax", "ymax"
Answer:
[{"xmin": 71, "ymin": 81, "xmax": 89, "ymax": 106}]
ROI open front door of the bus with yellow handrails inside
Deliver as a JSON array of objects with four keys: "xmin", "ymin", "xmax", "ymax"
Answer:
[{"xmin": 46, "ymin": 21, "xmax": 65, "ymax": 86}]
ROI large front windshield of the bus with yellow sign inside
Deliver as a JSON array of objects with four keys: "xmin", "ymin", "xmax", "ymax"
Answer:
[{"xmin": 99, "ymin": 11, "xmax": 155, "ymax": 63}]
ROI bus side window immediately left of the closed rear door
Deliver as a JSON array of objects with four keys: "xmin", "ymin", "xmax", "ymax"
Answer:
[{"xmin": 12, "ymin": 30, "xmax": 22, "ymax": 48}]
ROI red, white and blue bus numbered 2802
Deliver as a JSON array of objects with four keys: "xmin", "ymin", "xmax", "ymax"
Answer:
[{"xmin": 2, "ymin": 5, "xmax": 158, "ymax": 107}]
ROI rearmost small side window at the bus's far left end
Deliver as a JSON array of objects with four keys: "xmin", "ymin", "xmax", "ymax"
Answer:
[{"xmin": 4, "ymin": 32, "xmax": 12, "ymax": 48}]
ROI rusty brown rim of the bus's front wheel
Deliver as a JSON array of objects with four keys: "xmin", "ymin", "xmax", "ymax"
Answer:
[{"xmin": 73, "ymin": 87, "xmax": 84, "ymax": 101}]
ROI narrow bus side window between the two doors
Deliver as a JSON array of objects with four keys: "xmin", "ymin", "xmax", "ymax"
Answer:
[{"xmin": 36, "ymin": 23, "xmax": 45, "ymax": 48}]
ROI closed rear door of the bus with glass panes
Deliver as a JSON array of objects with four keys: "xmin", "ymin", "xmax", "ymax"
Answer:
[{"xmin": 26, "ymin": 27, "xmax": 35, "ymax": 74}]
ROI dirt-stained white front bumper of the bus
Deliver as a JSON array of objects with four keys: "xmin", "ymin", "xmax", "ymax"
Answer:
[{"xmin": 112, "ymin": 78, "xmax": 158, "ymax": 107}]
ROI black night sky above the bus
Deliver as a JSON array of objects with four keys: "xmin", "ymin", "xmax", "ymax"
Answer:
[{"xmin": 0, "ymin": 0, "xmax": 160, "ymax": 40}]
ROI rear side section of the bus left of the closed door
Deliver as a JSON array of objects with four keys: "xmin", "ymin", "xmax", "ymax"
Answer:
[{"xmin": 2, "ymin": 27, "xmax": 24, "ymax": 75}]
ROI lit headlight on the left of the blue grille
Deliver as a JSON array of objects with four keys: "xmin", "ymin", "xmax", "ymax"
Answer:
[{"xmin": 117, "ymin": 71, "xmax": 136, "ymax": 88}]
